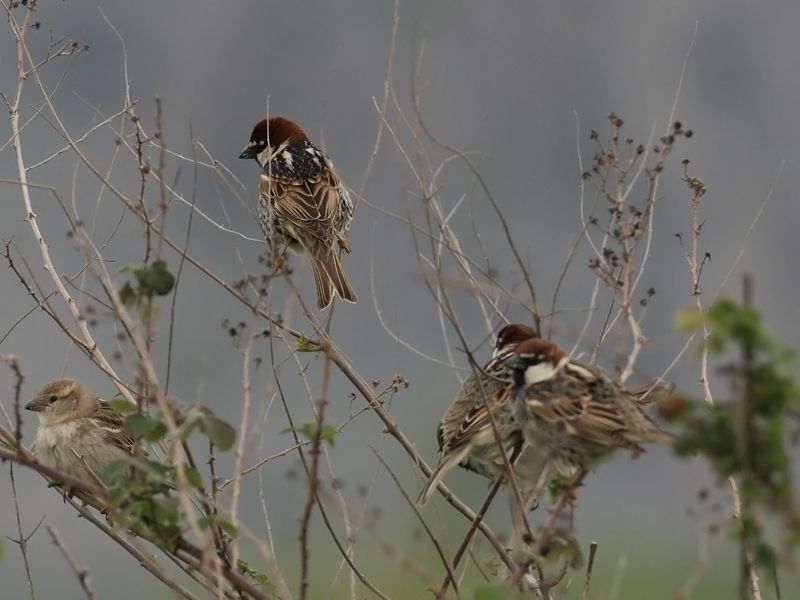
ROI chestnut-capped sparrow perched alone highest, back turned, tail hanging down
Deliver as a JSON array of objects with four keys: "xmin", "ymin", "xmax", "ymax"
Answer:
[{"xmin": 239, "ymin": 117, "xmax": 358, "ymax": 310}]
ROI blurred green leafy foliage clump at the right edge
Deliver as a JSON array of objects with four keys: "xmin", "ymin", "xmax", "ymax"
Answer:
[{"xmin": 676, "ymin": 298, "xmax": 800, "ymax": 572}]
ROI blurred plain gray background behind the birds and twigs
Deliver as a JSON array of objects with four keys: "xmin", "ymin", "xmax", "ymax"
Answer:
[{"xmin": 0, "ymin": 0, "xmax": 800, "ymax": 599}]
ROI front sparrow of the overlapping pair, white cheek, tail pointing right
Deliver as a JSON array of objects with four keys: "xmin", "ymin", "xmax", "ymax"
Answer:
[{"xmin": 502, "ymin": 338, "xmax": 674, "ymax": 474}]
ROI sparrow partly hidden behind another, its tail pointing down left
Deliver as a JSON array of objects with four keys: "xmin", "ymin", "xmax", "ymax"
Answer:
[{"xmin": 417, "ymin": 323, "xmax": 539, "ymax": 506}]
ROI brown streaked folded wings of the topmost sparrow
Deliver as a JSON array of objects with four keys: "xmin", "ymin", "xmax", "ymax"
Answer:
[{"xmin": 261, "ymin": 169, "xmax": 340, "ymax": 245}]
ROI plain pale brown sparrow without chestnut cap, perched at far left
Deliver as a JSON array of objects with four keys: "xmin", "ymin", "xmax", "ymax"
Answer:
[{"xmin": 25, "ymin": 379, "xmax": 136, "ymax": 484}]
